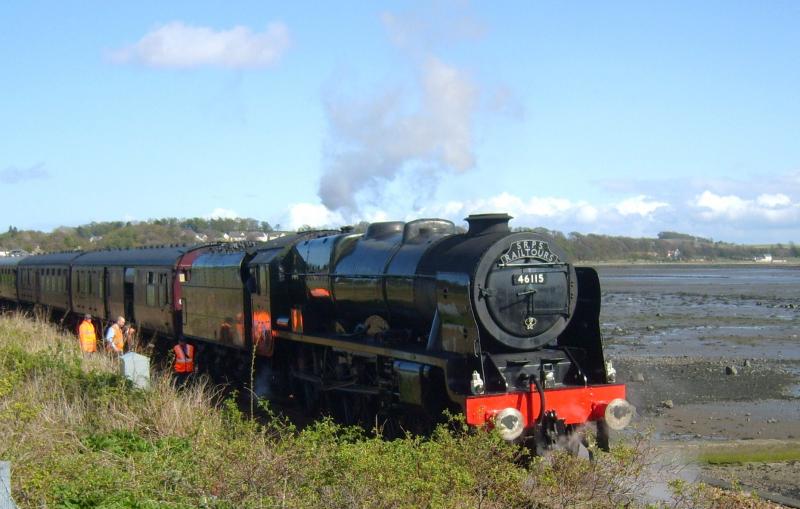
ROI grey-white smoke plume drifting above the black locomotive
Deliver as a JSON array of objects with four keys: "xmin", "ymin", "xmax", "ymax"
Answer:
[{"xmin": 319, "ymin": 56, "xmax": 478, "ymax": 214}]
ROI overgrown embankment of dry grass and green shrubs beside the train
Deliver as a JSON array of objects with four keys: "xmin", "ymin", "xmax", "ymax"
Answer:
[{"xmin": 0, "ymin": 315, "xmax": 776, "ymax": 508}]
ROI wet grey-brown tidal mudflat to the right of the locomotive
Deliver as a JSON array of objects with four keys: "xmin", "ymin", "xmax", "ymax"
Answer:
[{"xmin": 597, "ymin": 264, "xmax": 800, "ymax": 498}]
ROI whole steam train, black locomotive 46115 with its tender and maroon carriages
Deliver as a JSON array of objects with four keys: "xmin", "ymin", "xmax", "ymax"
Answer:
[{"xmin": 0, "ymin": 214, "xmax": 632, "ymax": 447}]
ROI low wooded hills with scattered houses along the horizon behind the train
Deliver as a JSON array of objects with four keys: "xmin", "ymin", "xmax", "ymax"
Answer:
[{"xmin": 0, "ymin": 217, "xmax": 800, "ymax": 262}]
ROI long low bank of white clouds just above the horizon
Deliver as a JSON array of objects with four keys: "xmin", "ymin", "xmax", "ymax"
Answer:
[{"xmin": 286, "ymin": 186, "xmax": 800, "ymax": 243}]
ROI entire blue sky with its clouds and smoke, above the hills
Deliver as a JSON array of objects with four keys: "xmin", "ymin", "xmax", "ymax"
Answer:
[{"xmin": 0, "ymin": 1, "xmax": 800, "ymax": 243}]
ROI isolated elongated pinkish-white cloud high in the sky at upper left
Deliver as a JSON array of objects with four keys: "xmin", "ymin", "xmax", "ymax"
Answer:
[{"xmin": 109, "ymin": 21, "xmax": 290, "ymax": 69}]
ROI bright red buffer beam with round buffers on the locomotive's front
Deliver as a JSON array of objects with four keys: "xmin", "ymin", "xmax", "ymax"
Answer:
[{"xmin": 465, "ymin": 384, "xmax": 632, "ymax": 436}]
